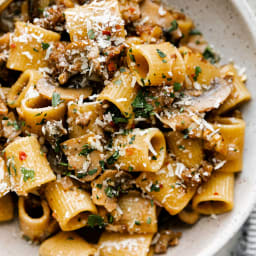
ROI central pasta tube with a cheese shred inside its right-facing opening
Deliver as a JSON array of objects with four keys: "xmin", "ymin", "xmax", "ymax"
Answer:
[{"xmin": 112, "ymin": 128, "xmax": 166, "ymax": 172}]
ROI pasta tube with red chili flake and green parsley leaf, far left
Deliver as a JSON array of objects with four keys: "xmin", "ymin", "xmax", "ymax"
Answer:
[{"xmin": 5, "ymin": 136, "xmax": 56, "ymax": 196}]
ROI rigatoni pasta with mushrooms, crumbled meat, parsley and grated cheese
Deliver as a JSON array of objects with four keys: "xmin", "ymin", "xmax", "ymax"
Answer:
[{"xmin": 0, "ymin": 0, "xmax": 251, "ymax": 256}]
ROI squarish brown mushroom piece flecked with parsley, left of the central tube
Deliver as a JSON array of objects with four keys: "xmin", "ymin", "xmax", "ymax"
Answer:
[{"xmin": 61, "ymin": 134, "xmax": 104, "ymax": 182}]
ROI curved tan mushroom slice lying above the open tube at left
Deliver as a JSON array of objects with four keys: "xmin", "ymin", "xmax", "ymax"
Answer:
[{"xmin": 36, "ymin": 78, "xmax": 92, "ymax": 101}]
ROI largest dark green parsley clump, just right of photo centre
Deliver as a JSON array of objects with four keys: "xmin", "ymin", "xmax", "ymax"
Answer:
[{"xmin": 132, "ymin": 91, "xmax": 153, "ymax": 118}]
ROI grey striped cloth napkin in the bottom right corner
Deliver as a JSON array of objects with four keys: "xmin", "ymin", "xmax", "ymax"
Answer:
[{"xmin": 233, "ymin": 206, "xmax": 256, "ymax": 256}]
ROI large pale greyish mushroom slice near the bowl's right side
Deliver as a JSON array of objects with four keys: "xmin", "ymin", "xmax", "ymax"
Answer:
[{"xmin": 182, "ymin": 78, "xmax": 231, "ymax": 113}]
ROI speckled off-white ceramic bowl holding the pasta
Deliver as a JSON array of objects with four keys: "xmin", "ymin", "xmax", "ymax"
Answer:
[{"xmin": 0, "ymin": 0, "xmax": 256, "ymax": 256}]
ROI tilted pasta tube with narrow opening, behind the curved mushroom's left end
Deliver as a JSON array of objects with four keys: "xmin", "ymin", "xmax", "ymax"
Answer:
[{"xmin": 7, "ymin": 70, "xmax": 43, "ymax": 108}]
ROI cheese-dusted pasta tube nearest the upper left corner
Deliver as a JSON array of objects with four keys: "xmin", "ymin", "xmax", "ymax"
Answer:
[{"xmin": 6, "ymin": 21, "xmax": 60, "ymax": 71}]
